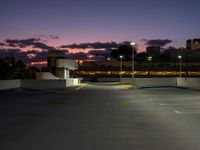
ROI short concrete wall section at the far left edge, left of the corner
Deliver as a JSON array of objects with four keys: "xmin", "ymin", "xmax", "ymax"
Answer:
[{"xmin": 0, "ymin": 80, "xmax": 20, "ymax": 90}]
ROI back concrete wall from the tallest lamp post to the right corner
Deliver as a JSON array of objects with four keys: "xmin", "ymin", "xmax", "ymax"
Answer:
[{"xmin": 122, "ymin": 78, "xmax": 176, "ymax": 87}]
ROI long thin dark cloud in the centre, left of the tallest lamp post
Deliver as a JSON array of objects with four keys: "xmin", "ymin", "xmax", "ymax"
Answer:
[{"xmin": 61, "ymin": 42, "xmax": 119, "ymax": 49}]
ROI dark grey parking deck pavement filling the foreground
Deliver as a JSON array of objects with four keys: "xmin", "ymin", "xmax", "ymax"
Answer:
[{"xmin": 0, "ymin": 83, "xmax": 200, "ymax": 150}]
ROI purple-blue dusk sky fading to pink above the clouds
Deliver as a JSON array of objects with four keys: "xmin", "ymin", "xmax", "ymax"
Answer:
[{"xmin": 0, "ymin": 0, "xmax": 200, "ymax": 63}]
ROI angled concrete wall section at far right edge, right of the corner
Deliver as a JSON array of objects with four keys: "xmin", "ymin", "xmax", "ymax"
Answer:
[{"xmin": 177, "ymin": 78, "xmax": 200, "ymax": 90}]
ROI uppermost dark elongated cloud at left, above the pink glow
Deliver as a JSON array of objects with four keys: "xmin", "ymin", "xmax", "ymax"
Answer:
[{"xmin": 5, "ymin": 38, "xmax": 56, "ymax": 51}]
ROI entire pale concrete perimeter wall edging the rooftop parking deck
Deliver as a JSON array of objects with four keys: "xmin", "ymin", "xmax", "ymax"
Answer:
[{"xmin": 0, "ymin": 78, "xmax": 200, "ymax": 90}]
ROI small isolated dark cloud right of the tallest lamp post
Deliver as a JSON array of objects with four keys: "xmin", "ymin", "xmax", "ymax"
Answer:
[{"xmin": 141, "ymin": 39, "xmax": 172, "ymax": 47}]
